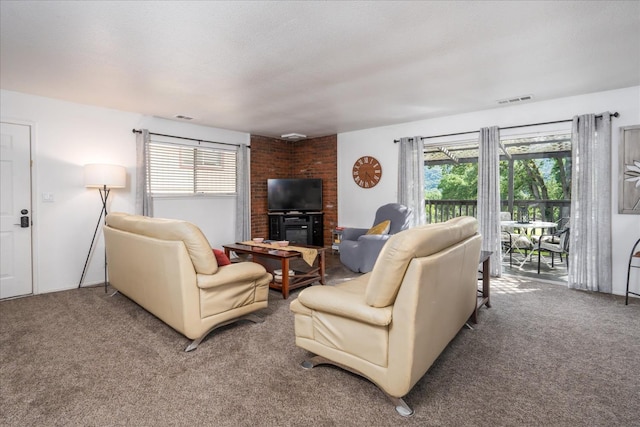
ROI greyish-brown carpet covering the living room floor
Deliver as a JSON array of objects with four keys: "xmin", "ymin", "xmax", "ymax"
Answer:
[{"xmin": 0, "ymin": 256, "xmax": 640, "ymax": 426}]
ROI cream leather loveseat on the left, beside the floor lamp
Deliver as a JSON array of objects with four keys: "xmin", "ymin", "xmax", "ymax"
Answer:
[{"xmin": 104, "ymin": 213, "xmax": 272, "ymax": 351}]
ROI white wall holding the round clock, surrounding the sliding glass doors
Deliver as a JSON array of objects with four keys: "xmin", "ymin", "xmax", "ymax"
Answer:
[{"xmin": 338, "ymin": 86, "xmax": 640, "ymax": 294}]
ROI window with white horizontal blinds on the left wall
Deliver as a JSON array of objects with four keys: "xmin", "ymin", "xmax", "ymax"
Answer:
[{"xmin": 148, "ymin": 141, "xmax": 236, "ymax": 195}]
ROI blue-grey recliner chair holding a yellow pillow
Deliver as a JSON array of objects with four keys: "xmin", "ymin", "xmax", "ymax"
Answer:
[{"xmin": 340, "ymin": 203, "xmax": 412, "ymax": 273}]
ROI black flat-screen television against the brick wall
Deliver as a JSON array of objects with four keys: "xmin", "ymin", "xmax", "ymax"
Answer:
[{"xmin": 267, "ymin": 178, "xmax": 322, "ymax": 212}]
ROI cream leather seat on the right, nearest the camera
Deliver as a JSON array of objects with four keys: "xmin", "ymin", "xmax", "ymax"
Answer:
[{"xmin": 291, "ymin": 217, "xmax": 481, "ymax": 416}]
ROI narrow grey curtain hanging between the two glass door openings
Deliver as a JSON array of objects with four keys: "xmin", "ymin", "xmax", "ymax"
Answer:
[{"xmin": 478, "ymin": 126, "xmax": 502, "ymax": 277}]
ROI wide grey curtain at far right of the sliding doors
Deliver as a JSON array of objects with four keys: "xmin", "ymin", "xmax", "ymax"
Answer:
[{"xmin": 568, "ymin": 112, "xmax": 612, "ymax": 293}]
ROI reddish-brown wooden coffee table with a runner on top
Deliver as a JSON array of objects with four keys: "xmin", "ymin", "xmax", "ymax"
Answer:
[{"xmin": 222, "ymin": 243, "xmax": 325, "ymax": 299}]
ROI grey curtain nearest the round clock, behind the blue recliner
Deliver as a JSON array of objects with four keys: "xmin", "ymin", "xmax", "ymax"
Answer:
[{"xmin": 398, "ymin": 136, "xmax": 427, "ymax": 227}]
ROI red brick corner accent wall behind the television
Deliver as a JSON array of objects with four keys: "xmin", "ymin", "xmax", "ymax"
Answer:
[{"xmin": 251, "ymin": 135, "xmax": 338, "ymax": 246}]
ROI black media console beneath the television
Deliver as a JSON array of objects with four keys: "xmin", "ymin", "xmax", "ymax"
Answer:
[{"xmin": 269, "ymin": 212, "xmax": 324, "ymax": 247}]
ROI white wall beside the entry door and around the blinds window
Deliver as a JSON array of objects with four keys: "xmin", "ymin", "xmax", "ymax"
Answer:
[{"xmin": 0, "ymin": 90, "xmax": 250, "ymax": 293}]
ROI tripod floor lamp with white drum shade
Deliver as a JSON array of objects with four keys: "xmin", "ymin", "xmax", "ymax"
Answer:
[{"xmin": 78, "ymin": 163, "xmax": 127, "ymax": 293}]
